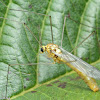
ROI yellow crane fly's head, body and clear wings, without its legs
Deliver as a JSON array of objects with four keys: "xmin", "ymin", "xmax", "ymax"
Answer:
[{"xmin": 41, "ymin": 43, "xmax": 100, "ymax": 92}]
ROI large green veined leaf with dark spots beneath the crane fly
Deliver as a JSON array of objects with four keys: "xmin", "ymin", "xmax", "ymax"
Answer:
[{"xmin": 0, "ymin": 0, "xmax": 100, "ymax": 100}]
